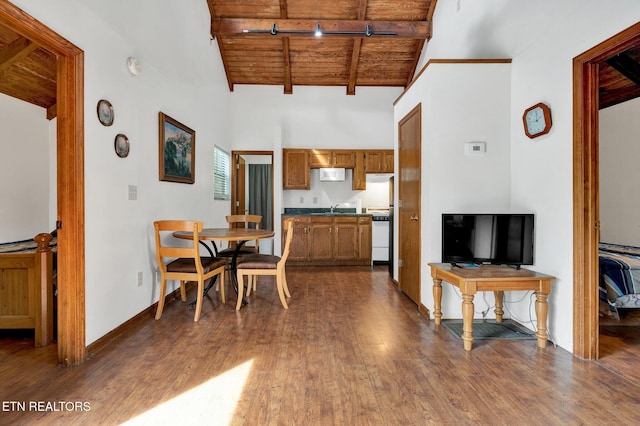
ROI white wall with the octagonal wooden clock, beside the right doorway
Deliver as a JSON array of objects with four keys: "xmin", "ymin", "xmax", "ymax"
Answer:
[{"xmin": 422, "ymin": 0, "xmax": 640, "ymax": 351}]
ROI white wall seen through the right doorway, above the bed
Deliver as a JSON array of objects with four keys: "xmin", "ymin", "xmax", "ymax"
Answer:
[{"xmin": 599, "ymin": 99, "xmax": 640, "ymax": 246}]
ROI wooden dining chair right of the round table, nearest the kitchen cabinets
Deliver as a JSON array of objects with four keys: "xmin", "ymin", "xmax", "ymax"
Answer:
[{"xmin": 236, "ymin": 220, "xmax": 293, "ymax": 310}]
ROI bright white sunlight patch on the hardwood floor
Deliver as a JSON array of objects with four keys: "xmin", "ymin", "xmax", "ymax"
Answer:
[{"xmin": 124, "ymin": 361, "xmax": 253, "ymax": 425}]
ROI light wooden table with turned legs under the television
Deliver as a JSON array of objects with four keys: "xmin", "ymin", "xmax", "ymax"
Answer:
[{"xmin": 429, "ymin": 263, "xmax": 555, "ymax": 351}]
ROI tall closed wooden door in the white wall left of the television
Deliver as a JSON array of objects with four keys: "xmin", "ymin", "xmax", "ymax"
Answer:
[{"xmin": 395, "ymin": 104, "xmax": 422, "ymax": 306}]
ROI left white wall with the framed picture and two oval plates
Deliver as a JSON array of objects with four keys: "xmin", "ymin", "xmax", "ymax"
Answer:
[{"xmin": 13, "ymin": 0, "xmax": 231, "ymax": 344}]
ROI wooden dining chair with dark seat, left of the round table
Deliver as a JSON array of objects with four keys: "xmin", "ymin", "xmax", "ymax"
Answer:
[{"xmin": 153, "ymin": 220, "xmax": 227, "ymax": 321}]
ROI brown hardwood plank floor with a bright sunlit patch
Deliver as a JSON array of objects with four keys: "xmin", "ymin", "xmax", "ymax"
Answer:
[{"xmin": 0, "ymin": 267, "xmax": 640, "ymax": 425}]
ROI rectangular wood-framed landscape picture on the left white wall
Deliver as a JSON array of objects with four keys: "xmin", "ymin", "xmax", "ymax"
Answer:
[{"xmin": 159, "ymin": 112, "xmax": 196, "ymax": 183}]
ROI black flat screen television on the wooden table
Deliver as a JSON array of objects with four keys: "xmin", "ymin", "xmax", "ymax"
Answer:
[{"xmin": 442, "ymin": 213, "xmax": 534, "ymax": 267}]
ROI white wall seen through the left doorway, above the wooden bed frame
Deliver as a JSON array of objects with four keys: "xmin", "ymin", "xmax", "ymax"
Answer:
[{"xmin": 0, "ymin": 94, "xmax": 53, "ymax": 243}]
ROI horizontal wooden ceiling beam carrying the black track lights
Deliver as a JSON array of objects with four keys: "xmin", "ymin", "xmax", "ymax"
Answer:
[{"xmin": 213, "ymin": 18, "xmax": 430, "ymax": 39}]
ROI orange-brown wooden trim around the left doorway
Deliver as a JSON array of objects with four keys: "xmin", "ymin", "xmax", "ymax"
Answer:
[{"xmin": 0, "ymin": 2, "xmax": 86, "ymax": 366}]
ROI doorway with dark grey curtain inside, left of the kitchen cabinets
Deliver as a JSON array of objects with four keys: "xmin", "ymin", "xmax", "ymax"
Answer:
[{"xmin": 231, "ymin": 151, "xmax": 274, "ymax": 254}]
